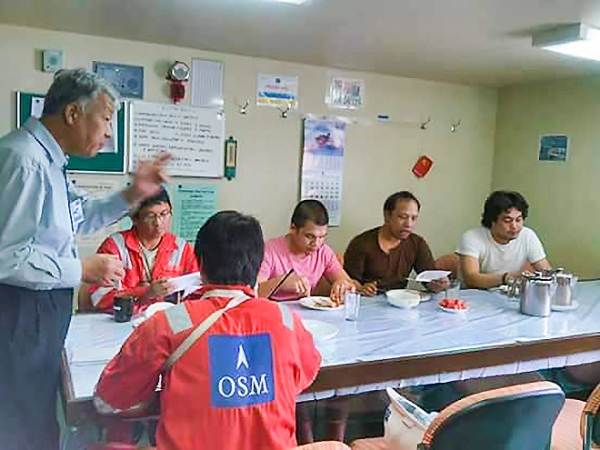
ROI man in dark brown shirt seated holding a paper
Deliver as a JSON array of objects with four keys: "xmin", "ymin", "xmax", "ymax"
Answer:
[{"xmin": 344, "ymin": 191, "xmax": 448, "ymax": 296}]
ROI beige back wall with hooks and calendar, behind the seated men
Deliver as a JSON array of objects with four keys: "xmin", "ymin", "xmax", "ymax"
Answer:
[{"xmin": 0, "ymin": 25, "xmax": 497, "ymax": 254}]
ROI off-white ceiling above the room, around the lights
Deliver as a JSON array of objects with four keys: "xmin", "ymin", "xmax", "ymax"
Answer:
[{"xmin": 0, "ymin": 0, "xmax": 600, "ymax": 86}]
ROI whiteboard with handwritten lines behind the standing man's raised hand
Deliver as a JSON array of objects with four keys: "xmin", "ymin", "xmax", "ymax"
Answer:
[{"xmin": 129, "ymin": 102, "xmax": 225, "ymax": 178}]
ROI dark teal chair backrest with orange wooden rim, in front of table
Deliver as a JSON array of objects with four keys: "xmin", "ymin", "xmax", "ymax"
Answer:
[{"xmin": 423, "ymin": 381, "xmax": 565, "ymax": 450}]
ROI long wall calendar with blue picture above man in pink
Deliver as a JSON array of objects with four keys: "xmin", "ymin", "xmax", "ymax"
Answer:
[{"xmin": 300, "ymin": 119, "xmax": 346, "ymax": 226}]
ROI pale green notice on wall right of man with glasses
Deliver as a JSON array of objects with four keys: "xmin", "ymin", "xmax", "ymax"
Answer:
[{"xmin": 169, "ymin": 183, "xmax": 218, "ymax": 243}]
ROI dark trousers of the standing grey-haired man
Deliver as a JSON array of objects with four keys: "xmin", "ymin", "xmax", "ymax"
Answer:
[{"xmin": 0, "ymin": 284, "xmax": 73, "ymax": 450}]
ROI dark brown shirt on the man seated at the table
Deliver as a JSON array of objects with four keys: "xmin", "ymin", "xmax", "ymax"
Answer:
[{"xmin": 344, "ymin": 227, "xmax": 435, "ymax": 289}]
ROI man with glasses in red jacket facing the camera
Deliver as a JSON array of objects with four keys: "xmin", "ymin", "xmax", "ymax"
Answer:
[{"xmin": 89, "ymin": 189, "xmax": 198, "ymax": 313}]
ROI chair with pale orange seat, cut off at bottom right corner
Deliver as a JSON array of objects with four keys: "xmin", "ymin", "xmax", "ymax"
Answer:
[{"xmin": 552, "ymin": 385, "xmax": 600, "ymax": 450}]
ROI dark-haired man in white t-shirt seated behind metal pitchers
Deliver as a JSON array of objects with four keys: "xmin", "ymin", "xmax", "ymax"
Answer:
[{"xmin": 456, "ymin": 191, "xmax": 551, "ymax": 289}]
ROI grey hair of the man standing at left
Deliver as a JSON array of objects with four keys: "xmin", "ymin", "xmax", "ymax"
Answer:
[{"xmin": 42, "ymin": 69, "xmax": 121, "ymax": 116}]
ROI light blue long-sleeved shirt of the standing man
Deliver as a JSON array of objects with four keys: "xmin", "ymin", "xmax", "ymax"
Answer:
[{"xmin": 0, "ymin": 118, "xmax": 128, "ymax": 290}]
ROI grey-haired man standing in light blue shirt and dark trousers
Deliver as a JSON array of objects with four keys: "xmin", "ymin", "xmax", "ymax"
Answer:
[{"xmin": 0, "ymin": 69, "xmax": 170, "ymax": 450}]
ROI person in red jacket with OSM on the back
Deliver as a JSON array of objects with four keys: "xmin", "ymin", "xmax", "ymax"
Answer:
[{"xmin": 94, "ymin": 211, "xmax": 321, "ymax": 450}]
